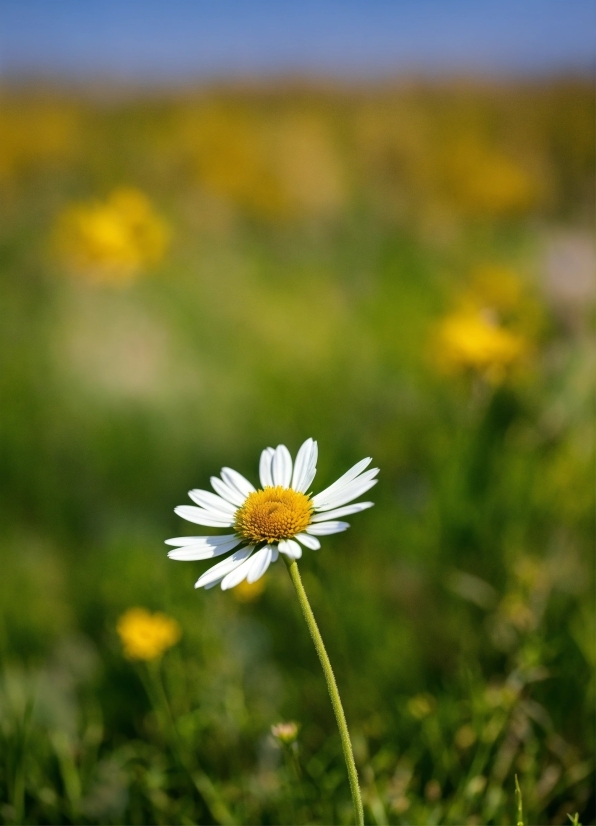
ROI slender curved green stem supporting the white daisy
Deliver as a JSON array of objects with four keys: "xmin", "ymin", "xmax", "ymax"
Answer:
[{"xmin": 284, "ymin": 555, "xmax": 364, "ymax": 826}]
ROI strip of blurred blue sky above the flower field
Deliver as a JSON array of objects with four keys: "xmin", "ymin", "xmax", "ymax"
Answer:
[{"xmin": 0, "ymin": 0, "xmax": 596, "ymax": 83}]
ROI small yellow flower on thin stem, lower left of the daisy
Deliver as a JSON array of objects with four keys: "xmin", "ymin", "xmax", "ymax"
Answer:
[{"xmin": 116, "ymin": 608, "xmax": 182, "ymax": 660}]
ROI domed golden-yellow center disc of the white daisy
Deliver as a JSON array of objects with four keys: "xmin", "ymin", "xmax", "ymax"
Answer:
[{"xmin": 234, "ymin": 485, "xmax": 312, "ymax": 543}]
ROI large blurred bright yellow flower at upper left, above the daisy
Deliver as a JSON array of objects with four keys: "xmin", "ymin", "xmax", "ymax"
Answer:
[{"xmin": 56, "ymin": 187, "xmax": 170, "ymax": 283}]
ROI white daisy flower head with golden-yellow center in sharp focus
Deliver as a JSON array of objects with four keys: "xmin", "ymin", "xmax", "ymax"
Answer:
[{"xmin": 166, "ymin": 439, "xmax": 379, "ymax": 591}]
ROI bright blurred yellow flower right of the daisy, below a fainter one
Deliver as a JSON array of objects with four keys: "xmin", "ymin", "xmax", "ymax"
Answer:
[{"xmin": 435, "ymin": 307, "xmax": 528, "ymax": 384}]
